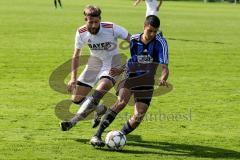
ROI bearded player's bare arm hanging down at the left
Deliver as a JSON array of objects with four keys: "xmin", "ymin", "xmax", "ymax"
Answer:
[{"xmin": 67, "ymin": 48, "xmax": 81, "ymax": 92}]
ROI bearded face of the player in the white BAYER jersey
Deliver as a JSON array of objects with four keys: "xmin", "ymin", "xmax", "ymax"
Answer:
[{"xmin": 85, "ymin": 16, "xmax": 101, "ymax": 34}]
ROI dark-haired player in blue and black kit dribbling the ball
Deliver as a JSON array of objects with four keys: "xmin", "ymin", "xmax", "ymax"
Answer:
[{"xmin": 90, "ymin": 15, "xmax": 169, "ymax": 147}]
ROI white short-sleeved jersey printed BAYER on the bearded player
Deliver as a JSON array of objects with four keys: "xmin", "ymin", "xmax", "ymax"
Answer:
[{"xmin": 75, "ymin": 22, "xmax": 128, "ymax": 60}]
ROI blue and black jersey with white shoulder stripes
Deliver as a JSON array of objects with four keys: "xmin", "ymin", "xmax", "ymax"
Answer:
[{"xmin": 128, "ymin": 33, "xmax": 168, "ymax": 77}]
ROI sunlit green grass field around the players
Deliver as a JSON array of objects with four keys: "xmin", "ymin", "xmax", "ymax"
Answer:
[{"xmin": 0, "ymin": 0, "xmax": 240, "ymax": 160}]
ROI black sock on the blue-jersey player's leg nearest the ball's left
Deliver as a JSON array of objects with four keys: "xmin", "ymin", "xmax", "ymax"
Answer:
[{"xmin": 95, "ymin": 109, "xmax": 117, "ymax": 137}]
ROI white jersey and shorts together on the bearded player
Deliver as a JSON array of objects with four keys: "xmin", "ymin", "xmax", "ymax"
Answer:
[{"xmin": 75, "ymin": 22, "xmax": 128, "ymax": 87}]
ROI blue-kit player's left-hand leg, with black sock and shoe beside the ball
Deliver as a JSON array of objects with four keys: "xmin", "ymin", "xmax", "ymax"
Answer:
[{"xmin": 90, "ymin": 88, "xmax": 131, "ymax": 147}]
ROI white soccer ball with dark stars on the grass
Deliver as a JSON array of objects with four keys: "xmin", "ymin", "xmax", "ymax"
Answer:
[{"xmin": 105, "ymin": 131, "xmax": 126, "ymax": 150}]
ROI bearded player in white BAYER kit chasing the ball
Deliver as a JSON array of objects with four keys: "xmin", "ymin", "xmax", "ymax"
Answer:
[{"xmin": 60, "ymin": 5, "xmax": 131, "ymax": 131}]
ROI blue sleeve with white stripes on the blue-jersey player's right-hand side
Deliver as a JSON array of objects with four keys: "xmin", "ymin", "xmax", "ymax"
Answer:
[{"xmin": 158, "ymin": 38, "xmax": 168, "ymax": 64}]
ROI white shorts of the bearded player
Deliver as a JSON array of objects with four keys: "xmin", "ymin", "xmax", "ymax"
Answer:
[{"xmin": 78, "ymin": 55, "xmax": 121, "ymax": 87}]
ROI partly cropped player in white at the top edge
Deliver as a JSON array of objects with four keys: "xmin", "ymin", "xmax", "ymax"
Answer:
[{"xmin": 134, "ymin": 0, "xmax": 163, "ymax": 17}]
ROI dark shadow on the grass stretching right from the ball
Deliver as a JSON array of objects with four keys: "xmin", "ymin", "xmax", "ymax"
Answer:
[{"xmin": 75, "ymin": 135, "xmax": 240, "ymax": 159}]
